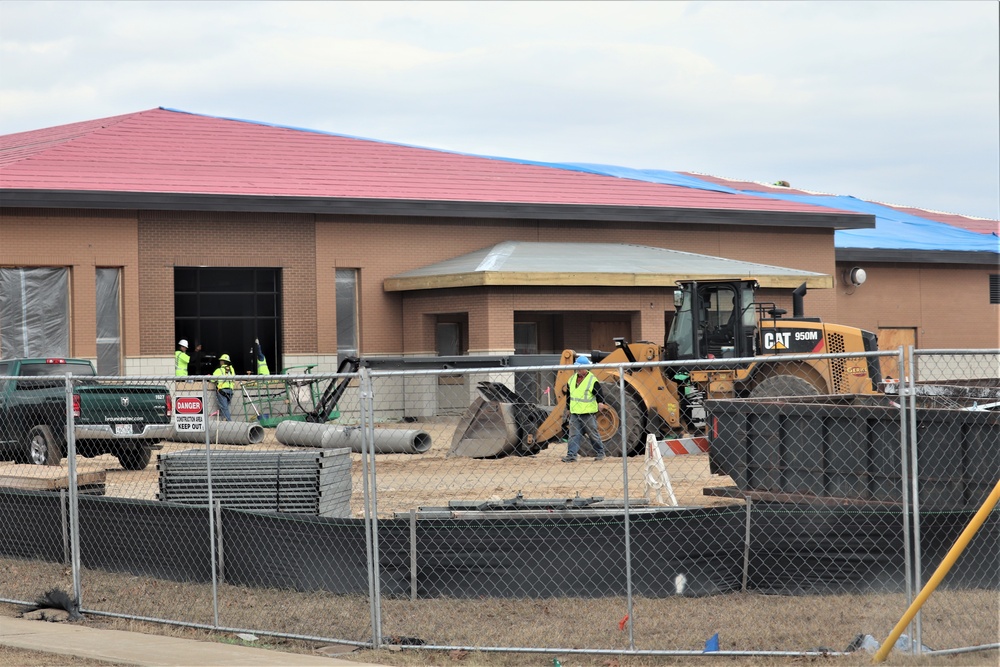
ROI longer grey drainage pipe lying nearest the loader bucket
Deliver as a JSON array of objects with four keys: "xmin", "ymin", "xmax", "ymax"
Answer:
[{"xmin": 274, "ymin": 421, "xmax": 431, "ymax": 454}]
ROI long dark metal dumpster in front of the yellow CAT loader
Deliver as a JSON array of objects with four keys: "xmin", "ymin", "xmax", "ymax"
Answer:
[{"xmin": 706, "ymin": 395, "xmax": 1000, "ymax": 509}]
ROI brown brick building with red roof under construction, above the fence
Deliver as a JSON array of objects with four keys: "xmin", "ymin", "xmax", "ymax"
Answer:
[{"xmin": 0, "ymin": 109, "xmax": 1000, "ymax": 374}]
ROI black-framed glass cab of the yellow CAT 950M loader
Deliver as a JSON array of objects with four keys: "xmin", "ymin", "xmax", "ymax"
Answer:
[{"xmin": 665, "ymin": 280, "xmax": 758, "ymax": 359}]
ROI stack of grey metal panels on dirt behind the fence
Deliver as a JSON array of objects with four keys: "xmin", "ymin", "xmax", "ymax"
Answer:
[{"xmin": 157, "ymin": 449, "xmax": 351, "ymax": 517}]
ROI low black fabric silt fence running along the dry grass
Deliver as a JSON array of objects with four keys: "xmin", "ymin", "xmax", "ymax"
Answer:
[{"xmin": 0, "ymin": 491, "xmax": 1000, "ymax": 598}]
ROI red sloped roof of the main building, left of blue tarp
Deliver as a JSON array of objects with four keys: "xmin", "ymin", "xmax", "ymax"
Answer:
[{"xmin": 0, "ymin": 108, "xmax": 850, "ymax": 215}]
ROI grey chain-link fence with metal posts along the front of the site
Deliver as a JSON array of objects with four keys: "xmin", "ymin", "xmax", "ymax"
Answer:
[{"xmin": 0, "ymin": 350, "xmax": 1000, "ymax": 654}]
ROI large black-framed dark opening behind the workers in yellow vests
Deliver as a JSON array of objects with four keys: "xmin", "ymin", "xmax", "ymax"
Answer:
[{"xmin": 174, "ymin": 267, "xmax": 283, "ymax": 375}]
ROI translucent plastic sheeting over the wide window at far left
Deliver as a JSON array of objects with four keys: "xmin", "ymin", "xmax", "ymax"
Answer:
[{"xmin": 0, "ymin": 268, "xmax": 69, "ymax": 359}]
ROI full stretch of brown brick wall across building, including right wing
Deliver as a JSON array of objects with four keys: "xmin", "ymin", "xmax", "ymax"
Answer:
[{"xmin": 0, "ymin": 209, "xmax": 1000, "ymax": 366}]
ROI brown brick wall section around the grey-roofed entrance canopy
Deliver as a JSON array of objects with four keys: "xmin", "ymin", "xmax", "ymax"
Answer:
[{"xmin": 316, "ymin": 216, "xmax": 835, "ymax": 355}]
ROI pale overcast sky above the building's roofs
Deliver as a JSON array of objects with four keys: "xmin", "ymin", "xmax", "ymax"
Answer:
[{"xmin": 0, "ymin": 0, "xmax": 1000, "ymax": 218}]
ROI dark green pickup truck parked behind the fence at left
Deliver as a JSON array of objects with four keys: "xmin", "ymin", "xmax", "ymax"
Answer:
[{"xmin": 0, "ymin": 358, "xmax": 174, "ymax": 470}]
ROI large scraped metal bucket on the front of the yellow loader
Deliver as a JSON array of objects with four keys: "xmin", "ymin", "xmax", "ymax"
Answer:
[{"xmin": 448, "ymin": 382, "xmax": 548, "ymax": 459}]
